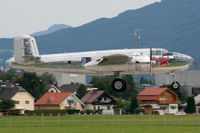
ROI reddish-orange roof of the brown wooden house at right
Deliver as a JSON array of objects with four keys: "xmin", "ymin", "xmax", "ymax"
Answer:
[{"xmin": 138, "ymin": 88, "xmax": 167, "ymax": 96}]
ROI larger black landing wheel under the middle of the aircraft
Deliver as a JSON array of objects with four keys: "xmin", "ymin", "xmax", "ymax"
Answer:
[{"xmin": 112, "ymin": 78, "xmax": 126, "ymax": 92}]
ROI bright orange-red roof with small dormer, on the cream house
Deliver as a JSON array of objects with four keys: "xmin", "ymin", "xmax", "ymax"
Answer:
[{"xmin": 35, "ymin": 92, "xmax": 71, "ymax": 105}]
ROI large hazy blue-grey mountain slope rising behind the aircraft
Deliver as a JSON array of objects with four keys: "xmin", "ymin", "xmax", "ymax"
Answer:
[{"xmin": 0, "ymin": 0, "xmax": 200, "ymax": 67}]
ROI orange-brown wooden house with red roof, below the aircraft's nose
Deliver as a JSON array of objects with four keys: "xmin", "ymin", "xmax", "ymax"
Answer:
[{"xmin": 137, "ymin": 88, "xmax": 178, "ymax": 114}]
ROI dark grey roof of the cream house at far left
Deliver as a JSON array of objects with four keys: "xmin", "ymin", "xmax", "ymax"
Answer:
[{"xmin": 0, "ymin": 86, "xmax": 27, "ymax": 99}]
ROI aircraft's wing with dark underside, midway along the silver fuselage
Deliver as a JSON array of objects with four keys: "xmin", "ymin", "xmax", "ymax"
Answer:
[{"xmin": 84, "ymin": 54, "xmax": 131, "ymax": 67}]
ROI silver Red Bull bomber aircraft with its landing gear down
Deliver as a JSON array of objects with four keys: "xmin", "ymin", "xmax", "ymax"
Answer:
[{"xmin": 6, "ymin": 35, "xmax": 193, "ymax": 92}]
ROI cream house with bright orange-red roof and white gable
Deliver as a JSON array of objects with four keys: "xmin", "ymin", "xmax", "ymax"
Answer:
[{"xmin": 35, "ymin": 92, "xmax": 84, "ymax": 110}]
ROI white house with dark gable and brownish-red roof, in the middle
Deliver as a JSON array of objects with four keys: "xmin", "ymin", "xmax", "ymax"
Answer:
[{"xmin": 81, "ymin": 90, "xmax": 116, "ymax": 114}]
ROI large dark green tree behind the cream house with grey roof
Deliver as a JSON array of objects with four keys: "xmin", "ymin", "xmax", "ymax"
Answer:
[{"xmin": 15, "ymin": 72, "xmax": 46, "ymax": 100}]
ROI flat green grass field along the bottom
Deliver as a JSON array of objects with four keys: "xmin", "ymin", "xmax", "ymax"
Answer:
[{"xmin": 0, "ymin": 115, "xmax": 200, "ymax": 133}]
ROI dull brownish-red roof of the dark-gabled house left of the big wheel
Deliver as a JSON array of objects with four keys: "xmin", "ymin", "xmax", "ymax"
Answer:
[{"xmin": 81, "ymin": 90, "xmax": 105, "ymax": 103}]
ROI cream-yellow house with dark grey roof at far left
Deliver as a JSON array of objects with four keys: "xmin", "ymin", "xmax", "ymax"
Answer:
[{"xmin": 0, "ymin": 85, "xmax": 34, "ymax": 114}]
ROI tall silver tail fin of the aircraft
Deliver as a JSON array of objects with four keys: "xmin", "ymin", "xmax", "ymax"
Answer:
[{"xmin": 14, "ymin": 35, "xmax": 39, "ymax": 64}]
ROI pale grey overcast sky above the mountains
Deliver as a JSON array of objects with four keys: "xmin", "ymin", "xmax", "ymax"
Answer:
[{"xmin": 0, "ymin": 0, "xmax": 161, "ymax": 38}]
